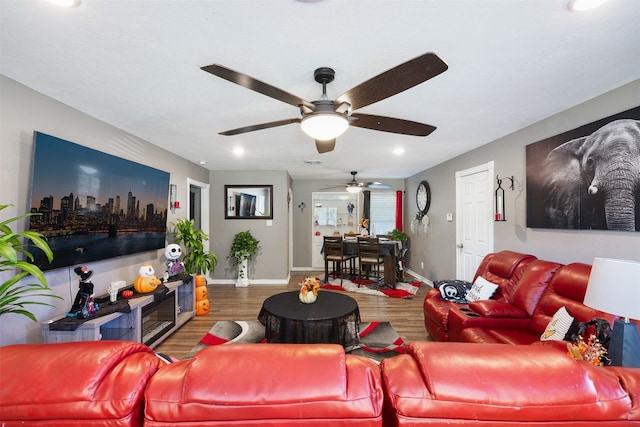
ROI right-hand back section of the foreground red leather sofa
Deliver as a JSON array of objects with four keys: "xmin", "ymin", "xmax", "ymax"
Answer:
[{"xmin": 381, "ymin": 342, "xmax": 634, "ymax": 425}]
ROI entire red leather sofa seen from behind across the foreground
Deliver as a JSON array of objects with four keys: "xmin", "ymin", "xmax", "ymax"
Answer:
[{"xmin": 0, "ymin": 341, "xmax": 640, "ymax": 427}]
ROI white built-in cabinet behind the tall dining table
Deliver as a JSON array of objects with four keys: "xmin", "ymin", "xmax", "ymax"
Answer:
[{"xmin": 311, "ymin": 191, "xmax": 360, "ymax": 268}]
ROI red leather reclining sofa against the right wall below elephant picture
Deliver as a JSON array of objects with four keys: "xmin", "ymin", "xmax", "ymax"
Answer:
[{"xmin": 423, "ymin": 251, "xmax": 628, "ymax": 349}]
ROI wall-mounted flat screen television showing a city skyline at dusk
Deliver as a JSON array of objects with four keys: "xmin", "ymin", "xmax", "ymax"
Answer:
[{"xmin": 29, "ymin": 132, "xmax": 169, "ymax": 270}]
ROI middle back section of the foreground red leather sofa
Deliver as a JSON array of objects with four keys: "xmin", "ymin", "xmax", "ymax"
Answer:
[{"xmin": 145, "ymin": 344, "xmax": 383, "ymax": 426}]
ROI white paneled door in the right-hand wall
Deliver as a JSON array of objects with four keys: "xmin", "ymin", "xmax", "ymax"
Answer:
[{"xmin": 456, "ymin": 162, "xmax": 493, "ymax": 281}]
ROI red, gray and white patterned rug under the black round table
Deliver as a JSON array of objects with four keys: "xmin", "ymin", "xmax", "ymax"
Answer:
[{"xmin": 185, "ymin": 320, "xmax": 405, "ymax": 362}]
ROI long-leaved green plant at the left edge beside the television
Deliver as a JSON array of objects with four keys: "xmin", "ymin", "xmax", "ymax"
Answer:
[{"xmin": 0, "ymin": 205, "xmax": 62, "ymax": 322}]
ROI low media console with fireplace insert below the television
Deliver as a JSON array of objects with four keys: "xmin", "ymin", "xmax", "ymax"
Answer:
[{"xmin": 40, "ymin": 280, "xmax": 195, "ymax": 348}]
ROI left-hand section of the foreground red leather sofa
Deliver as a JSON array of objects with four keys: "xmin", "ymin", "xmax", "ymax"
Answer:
[{"xmin": 0, "ymin": 341, "xmax": 164, "ymax": 427}]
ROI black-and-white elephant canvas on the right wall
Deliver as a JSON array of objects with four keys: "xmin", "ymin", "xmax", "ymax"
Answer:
[{"xmin": 527, "ymin": 107, "xmax": 640, "ymax": 231}]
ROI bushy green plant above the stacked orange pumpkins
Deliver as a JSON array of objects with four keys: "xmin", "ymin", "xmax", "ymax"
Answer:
[{"xmin": 171, "ymin": 219, "xmax": 218, "ymax": 274}]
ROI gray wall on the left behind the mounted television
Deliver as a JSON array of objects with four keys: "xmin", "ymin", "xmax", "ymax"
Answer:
[{"xmin": 0, "ymin": 76, "xmax": 209, "ymax": 345}]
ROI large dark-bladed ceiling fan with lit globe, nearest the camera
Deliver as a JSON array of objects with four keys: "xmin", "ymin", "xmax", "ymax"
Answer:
[{"xmin": 201, "ymin": 52, "xmax": 449, "ymax": 153}]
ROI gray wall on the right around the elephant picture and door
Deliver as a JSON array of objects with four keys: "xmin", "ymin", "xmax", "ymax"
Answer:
[{"xmin": 405, "ymin": 80, "xmax": 640, "ymax": 280}]
